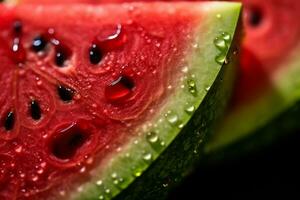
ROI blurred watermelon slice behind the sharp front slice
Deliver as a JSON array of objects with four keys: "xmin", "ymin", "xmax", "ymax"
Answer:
[{"xmin": 206, "ymin": 0, "xmax": 300, "ymax": 158}]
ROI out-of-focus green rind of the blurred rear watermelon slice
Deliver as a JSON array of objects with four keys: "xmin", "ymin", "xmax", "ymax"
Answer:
[{"xmin": 205, "ymin": 45, "xmax": 300, "ymax": 156}]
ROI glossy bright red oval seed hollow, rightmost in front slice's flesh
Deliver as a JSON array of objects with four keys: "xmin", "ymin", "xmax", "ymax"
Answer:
[{"xmin": 105, "ymin": 76, "xmax": 135, "ymax": 101}]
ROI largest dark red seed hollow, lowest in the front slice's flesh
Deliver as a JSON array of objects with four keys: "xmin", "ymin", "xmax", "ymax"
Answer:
[{"xmin": 50, "ymin": 123, "xmax": 89, "ymax": 160}]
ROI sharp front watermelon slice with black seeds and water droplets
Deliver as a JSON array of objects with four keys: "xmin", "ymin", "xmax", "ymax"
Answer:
[{"xmin": 0, "ymin": 3, "xmax": 241, "ymax": 200}]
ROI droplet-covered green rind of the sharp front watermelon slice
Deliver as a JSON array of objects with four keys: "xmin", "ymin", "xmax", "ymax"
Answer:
[{"xmin": 68, "ymin": 3, "xmax": 241, "ymax": 200}]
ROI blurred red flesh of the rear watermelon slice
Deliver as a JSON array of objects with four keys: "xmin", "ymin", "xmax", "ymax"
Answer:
[{"xmin": 8, "ymin": 0, "xmax": 300, "ymax": 112}]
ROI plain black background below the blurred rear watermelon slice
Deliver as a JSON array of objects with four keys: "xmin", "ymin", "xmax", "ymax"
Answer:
[{"xmin": 169, "ymin": 131, "xmax": 300, "ymax": 200}]
